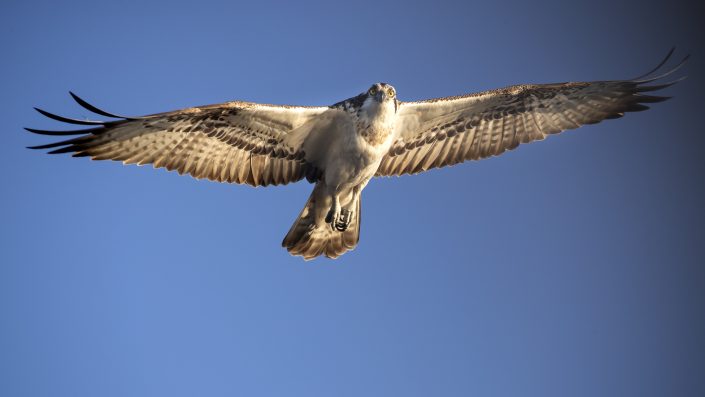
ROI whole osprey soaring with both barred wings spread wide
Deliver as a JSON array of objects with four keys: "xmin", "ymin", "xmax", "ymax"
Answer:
[{"xmin": 27, "ymin": 49, "xmax": 688, "ymax": 259}]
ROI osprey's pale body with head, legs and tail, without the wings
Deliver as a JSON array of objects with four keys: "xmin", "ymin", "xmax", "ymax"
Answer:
[{"xmin": 282, "ymin": 83, "xmax": 398, "ymax": 258}]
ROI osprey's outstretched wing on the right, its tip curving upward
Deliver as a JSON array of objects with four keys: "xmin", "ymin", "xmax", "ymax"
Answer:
[{"xmin": 376, "ymin": 50, "xmax": 688, "ymax": 176}]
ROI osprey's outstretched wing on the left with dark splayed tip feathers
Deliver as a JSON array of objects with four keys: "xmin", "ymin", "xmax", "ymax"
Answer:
[{"xmin": 27, "ymin": 93, "xmax": 337, "ymax": 186}]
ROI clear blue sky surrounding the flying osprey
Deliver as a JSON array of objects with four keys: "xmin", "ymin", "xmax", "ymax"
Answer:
[{"xmin": 0, "ymin": 0, "xmax": 705, "ymax": 397}]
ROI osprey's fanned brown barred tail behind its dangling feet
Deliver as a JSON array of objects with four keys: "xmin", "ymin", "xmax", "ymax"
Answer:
[{"xmin": 282, "ymin": 182, "xmax": 360, "ymax": 260}]
